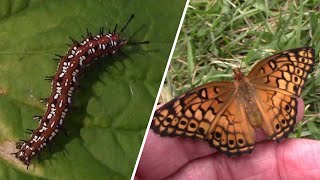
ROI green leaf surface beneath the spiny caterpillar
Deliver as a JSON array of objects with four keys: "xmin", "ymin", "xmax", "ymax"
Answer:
[{"xmin": 0, "ymin": 0, "xmax": 185, "ymax": 179}]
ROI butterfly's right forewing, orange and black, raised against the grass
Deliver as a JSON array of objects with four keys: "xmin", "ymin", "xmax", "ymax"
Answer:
[{"xmin": 248, "ymin": 47, "xmax": 314, "ymax": 96}]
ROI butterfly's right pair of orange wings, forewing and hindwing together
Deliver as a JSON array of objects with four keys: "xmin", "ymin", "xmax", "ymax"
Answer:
[{"xmin": 248, "ymin": 47, "xmax": 315, "ymax": 141}]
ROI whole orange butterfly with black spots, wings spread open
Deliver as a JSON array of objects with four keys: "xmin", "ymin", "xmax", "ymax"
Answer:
[{"xmin": 151, "ymin": 47, "xmax": 315, "ymax": 156}]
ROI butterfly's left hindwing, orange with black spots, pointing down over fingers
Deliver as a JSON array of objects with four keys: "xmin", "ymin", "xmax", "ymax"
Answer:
[{"xmin": 206, "ymin": 96, "xmax": 255, "ymax": 156}]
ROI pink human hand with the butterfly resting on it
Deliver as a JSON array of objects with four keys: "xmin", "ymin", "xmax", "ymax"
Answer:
[{"xmin": 135, "ymin": 98, "xmax": 320, "ymax": 180}]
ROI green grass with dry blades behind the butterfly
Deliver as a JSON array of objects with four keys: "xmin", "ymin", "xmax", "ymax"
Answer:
[{"xmin": 160, "ymin": 0, "xmax": 320, "ymax": 140}]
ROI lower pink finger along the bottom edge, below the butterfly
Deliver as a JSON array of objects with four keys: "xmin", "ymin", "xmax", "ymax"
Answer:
[{"xmin": 167, "ymin": 139, "xmax": 320, "ymax": 180}]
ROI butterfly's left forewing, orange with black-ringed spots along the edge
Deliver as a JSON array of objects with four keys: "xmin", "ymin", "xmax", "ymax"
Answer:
[{"xmin": 151, "ymin": 82, "xmax": 234, "ymax": 139}]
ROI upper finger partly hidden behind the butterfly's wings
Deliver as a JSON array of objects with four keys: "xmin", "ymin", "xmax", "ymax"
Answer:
[{"xmin": 137, "ymin": 98, "xmax": 304, "ymax": 180}]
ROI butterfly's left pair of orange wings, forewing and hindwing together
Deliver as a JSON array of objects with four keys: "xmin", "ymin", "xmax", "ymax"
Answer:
[{"xmin": 151, "ymin": 82, "xmax": 255, "ymax": 156}]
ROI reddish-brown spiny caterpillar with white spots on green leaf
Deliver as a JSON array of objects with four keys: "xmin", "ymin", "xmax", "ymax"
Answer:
[{"xmin": 12, "ymin": 15, "xmax": 149, "ymax": 169}]
